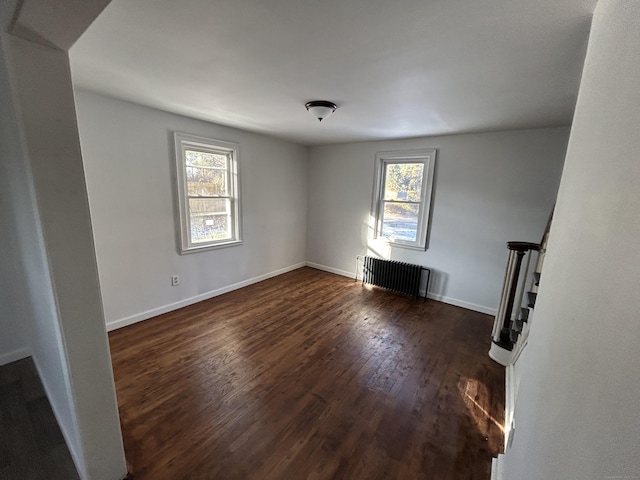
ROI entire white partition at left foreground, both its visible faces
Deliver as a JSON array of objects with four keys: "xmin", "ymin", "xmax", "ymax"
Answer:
[{"xmin": 0, "ymin": 1, "xmax": 126, "ymax": 480}]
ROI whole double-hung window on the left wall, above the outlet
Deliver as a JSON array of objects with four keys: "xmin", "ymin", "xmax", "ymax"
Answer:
[{"xmin": 175, "ymin": 132, "xmax": 242, "ymax": 253}]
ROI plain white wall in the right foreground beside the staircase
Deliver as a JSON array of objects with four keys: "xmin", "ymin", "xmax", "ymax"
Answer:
[{"xmin": 504, "ymin": 0, "xmax": 640, "ymax": 480}]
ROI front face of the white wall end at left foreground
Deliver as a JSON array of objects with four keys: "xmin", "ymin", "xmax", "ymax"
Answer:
[{"xmin": 8, "ymin": 29, "xmax": 126, "ymax": 480}]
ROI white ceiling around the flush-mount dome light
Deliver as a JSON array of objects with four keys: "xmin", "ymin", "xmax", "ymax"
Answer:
[{"xmin": 70, "ymin": 0, "xmax": 597, "ymax": 145}]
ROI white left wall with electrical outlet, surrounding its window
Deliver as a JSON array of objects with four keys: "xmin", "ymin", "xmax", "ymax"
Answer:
[{"xmin": 76, "ymin": 91, "xmax": 307, "ymax": 328}]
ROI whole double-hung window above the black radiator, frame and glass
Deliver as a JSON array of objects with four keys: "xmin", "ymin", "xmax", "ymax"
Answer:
[{"xmin": 371, "ymin": 149, "xmax": 436, "ymax": 250}]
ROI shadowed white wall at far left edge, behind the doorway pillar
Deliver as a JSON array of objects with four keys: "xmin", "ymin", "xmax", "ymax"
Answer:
[{"xmin": 0, "ymin": 1, "xmax": 83, "ymax": 465}]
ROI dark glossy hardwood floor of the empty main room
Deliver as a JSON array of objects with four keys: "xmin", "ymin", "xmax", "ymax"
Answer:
[{"xmin": 109, "ymin": 268, "xmax": 504, "ymax": 480}]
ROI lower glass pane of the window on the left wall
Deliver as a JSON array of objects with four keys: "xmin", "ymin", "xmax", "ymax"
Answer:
[{"xmin": 189, "ymin": 198, "xmax": 233, "ymax": 243}]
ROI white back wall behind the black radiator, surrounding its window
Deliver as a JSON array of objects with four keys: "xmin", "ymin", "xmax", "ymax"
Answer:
[{"xmin": 308, "ymin": 128, "xmax": 568, "ymax": 313}]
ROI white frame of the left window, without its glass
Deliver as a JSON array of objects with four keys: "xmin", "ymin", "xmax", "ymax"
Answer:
[{"xmin": 174, "ymin": 132, "xmax": 242, "ymax": 254}]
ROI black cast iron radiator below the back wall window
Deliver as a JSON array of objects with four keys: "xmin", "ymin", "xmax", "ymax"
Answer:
[{"xmin": 356, "ymin": 255, "xmax": 431, "ymax": 301}]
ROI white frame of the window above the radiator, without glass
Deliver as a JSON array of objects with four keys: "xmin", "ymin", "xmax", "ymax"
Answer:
[{"xmin": 371, "ymin": 148, "xmax": 436, "ymax": 250}]
